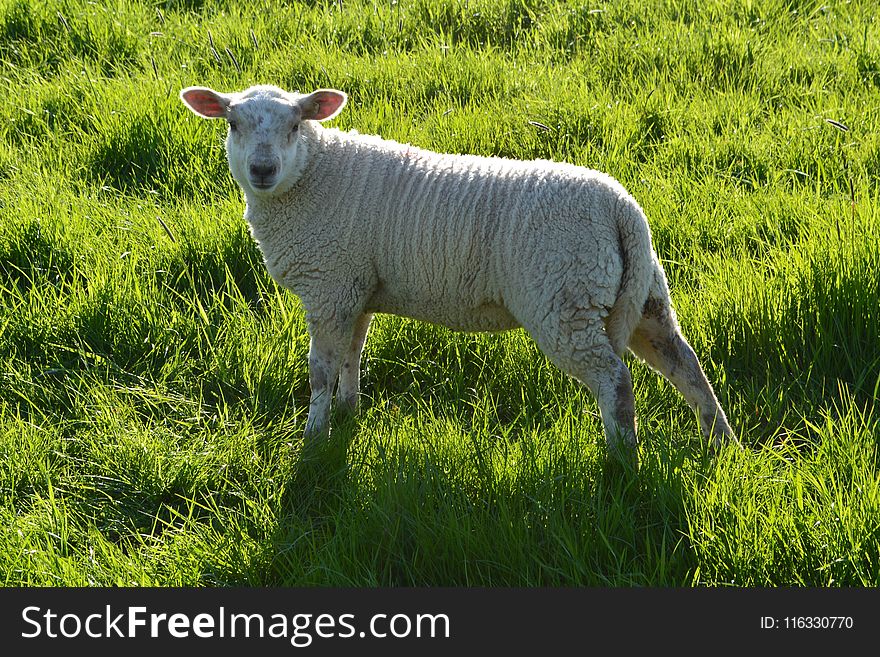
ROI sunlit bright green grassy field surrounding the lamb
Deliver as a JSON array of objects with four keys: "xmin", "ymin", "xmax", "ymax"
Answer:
[{"xmin": 0, "ymin": 0, "xmax": 880, "ymax": 586}]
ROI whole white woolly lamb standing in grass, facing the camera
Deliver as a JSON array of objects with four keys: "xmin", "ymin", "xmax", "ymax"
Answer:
[{"xmin": 180, "ymin": 85, "xmax": 736, "ymax": 459}]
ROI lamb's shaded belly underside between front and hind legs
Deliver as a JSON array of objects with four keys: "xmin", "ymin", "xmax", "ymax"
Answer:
[{"xmin": 367, "ymin": 293, "xmax": 519, "ymax": 332}]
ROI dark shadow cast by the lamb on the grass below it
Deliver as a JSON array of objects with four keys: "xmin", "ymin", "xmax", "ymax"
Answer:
[{"xmin": 262, "ymin": 423, "xmax": 699, "ymax": 586}]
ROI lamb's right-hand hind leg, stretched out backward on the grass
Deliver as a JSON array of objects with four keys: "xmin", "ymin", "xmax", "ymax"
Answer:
[{"xmin": 629, "ymin": 291, "xmax": 737, "ymax": 447}]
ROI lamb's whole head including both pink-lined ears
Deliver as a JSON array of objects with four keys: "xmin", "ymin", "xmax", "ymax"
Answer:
[{"xmin": 180, "ymin": 86, "xmax": 346, "ymax": 195}]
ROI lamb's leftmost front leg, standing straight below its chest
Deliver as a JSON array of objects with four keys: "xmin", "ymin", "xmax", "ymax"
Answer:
[{"xmin": 305, "ymin": 322, "xmax": 354, "ymax": 438}]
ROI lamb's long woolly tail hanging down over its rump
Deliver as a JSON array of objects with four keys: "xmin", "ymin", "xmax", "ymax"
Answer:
[{"xmin": 605, "ymin": 197, "xmax": 656, "ymax": 354}]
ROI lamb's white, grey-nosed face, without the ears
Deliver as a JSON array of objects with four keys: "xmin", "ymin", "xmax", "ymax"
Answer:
[{"xmin": 226, "ymin": 92, "xmax": 303, "ymax": 194}]
